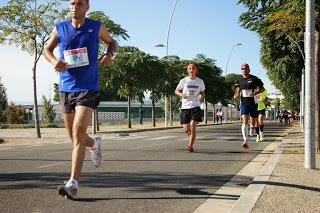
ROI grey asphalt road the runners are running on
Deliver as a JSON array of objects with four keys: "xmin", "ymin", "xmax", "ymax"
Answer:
[{"xmin": 0, "ymin": 123, "xmax": 285, "ymax": 213}]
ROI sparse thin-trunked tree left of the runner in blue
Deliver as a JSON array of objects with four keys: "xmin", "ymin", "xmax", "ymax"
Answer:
[{"xmin": 0, "ymin": 0, "xmax": 67, "ymax": 138}]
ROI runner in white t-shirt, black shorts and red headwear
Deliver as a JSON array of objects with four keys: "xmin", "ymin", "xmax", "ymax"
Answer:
[{"xmin": 175, "ymin": 64, "xmax": 205, "ymax": 152}]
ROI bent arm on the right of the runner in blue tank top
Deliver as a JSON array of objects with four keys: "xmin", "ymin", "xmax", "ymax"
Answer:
[{"xmin": 99, "ymin": 24, "xmax": 117, "ymax": 64}]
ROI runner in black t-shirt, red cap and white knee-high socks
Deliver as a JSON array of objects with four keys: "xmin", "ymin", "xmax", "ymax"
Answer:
[{"xmin": 234, "ymin": 64, "xmax": 265, "ymax": 149}]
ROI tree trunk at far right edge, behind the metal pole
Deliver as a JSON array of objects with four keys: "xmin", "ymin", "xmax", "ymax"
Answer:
[{"xmin": 314, "ymin": 31, "xmax": 320, "ymax": 152}]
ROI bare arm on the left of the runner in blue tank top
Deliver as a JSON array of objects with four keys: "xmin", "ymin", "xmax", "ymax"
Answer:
[{"xmin": 44, "ymin": 28, "xmax": 68, "ymax": 72}]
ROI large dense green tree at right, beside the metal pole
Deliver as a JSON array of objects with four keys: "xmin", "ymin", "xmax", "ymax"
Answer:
[{"xmin": 238, "ymin": 0, "xmax": 319, "ymax": 109}]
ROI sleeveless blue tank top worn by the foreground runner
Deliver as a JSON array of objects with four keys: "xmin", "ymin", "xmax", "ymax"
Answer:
[{"xmin": 56, "ymin": 19, "xmax": 101, "ymax": 92}]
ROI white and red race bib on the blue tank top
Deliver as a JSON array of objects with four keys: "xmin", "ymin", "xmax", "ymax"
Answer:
[{"xmin": 63, "ymin": 47, "xmax": 89, "ymax": 68}]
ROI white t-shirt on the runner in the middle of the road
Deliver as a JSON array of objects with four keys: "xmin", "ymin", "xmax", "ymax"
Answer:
[{"xmin": 177, "ymin": 76, "xmax": 205, "ymax": 109}]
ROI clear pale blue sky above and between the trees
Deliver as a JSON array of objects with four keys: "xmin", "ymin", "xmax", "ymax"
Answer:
[{"xmin": 0, "ymin": 0, "xmax": 276, "ymax": 104}]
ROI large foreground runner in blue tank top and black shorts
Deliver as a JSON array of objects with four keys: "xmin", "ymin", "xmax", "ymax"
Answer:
[{"xmin": 44, "ymin": 0, "xmax": 116, "ymax": 199}]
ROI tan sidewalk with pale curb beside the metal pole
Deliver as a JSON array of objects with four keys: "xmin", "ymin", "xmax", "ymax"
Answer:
[{"xmin": 231, "ymin": 124, "xmax": 320, "ymax": 213}]
